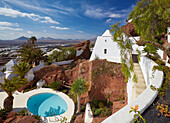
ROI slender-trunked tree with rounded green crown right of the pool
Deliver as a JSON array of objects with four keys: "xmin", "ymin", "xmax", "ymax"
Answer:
[{"xmin": 71, "ymin": 78, "xmax": 89, "ymax": 113}]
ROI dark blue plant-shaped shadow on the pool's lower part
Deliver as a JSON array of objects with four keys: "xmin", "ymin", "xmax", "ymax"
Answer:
[{"xmin": 45, "ymin": 106, "xmax": 65, "ymax": 117}]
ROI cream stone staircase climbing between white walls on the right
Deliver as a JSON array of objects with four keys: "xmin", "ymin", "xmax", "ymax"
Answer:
[{"xmin": 133, "ymin": 63, "xmax": 146, "ymax": 98}]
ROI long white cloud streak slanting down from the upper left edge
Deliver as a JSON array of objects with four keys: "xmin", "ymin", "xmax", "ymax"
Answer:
[{"xmin": 0, "ymin": 7, "xmax": 59, "ymax": 24}]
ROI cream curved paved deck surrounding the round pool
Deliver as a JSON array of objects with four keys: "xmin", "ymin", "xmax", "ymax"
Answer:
[{"xmin": 0, "ymin": 88, "xmax": 75, "ymax": 123}]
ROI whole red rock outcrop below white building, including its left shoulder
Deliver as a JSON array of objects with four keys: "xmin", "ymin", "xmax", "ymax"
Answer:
[{"xmin": 65, "ymin": 60, "xmax": 126, "ymax": 104}]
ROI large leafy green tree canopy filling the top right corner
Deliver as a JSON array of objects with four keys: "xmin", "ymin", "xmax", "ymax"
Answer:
[{"xmin": 129, "ymin": 0, "xmax": 170, "ymax": 40}]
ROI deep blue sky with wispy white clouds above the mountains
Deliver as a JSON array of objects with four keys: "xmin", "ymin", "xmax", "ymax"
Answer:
[{"xmin": 0, "ymin": 0, "xmax": 137, "ymax": 40}]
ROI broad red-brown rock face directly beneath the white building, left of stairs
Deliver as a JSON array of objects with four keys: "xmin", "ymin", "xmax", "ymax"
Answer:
[{"xmin": 82, "ymin": 60, "xmax": 126, "ymax": 102}]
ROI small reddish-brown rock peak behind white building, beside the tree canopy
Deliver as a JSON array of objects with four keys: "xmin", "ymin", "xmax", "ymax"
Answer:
[{"xmin": 122, "ymin": 22, "xmax": 138, "ymax": 36}]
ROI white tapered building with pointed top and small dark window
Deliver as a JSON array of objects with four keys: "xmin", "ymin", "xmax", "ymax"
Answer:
[{"xmin": 90, "ymin": 30, "xmax": 121, "ymax": 63}]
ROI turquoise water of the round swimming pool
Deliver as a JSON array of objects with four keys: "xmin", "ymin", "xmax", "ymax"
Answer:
[{"xmin": 27, "ymin": 93, "xmax": 68, "ymax": 117}]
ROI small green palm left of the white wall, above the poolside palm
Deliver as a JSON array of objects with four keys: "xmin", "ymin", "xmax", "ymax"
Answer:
[{"xmin": 13, "ymin": 62, "xmax": 31, "ymax": 79}]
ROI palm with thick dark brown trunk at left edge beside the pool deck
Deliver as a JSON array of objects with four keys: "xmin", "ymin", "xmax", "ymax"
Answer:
[{"xmin": 0, "ymin": 77, "xmax": 27, "ymax": 111}]
